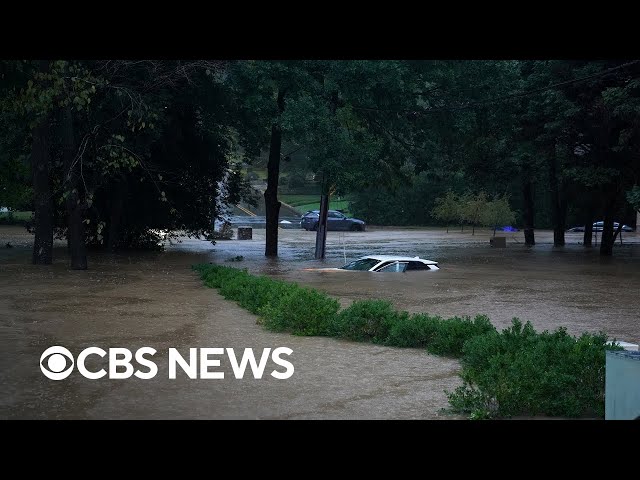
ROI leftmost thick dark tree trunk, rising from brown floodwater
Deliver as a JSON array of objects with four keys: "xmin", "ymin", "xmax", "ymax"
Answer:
[{"xmin": 31, "ymin": 60, "xmax": 53, "ymax": 265}]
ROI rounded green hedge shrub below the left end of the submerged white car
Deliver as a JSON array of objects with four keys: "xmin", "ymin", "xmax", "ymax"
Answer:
[{"xmin": 330, "ymin": 300, "xmax": 400, "ymax": 343}]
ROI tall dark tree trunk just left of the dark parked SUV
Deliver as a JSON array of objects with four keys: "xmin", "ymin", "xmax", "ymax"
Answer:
[{"xmin": 264, "ymin": 90, "xmax": 285, "ymax": 257}]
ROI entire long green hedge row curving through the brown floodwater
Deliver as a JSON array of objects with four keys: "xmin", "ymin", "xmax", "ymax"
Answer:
[{"xmin": 194, "ymin": 264, "xmax": 620, "ymax": 418}]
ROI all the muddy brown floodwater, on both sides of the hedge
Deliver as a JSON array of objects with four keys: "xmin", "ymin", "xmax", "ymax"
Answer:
[{"xmin": 0, "ymin": 227, "xmax": 640, "ymax": 419}]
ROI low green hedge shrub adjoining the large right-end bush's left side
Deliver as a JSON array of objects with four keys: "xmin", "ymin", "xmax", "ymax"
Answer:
[{"xmin": 427, "ymin": 315, "xmax": 496, "ymax": 357}]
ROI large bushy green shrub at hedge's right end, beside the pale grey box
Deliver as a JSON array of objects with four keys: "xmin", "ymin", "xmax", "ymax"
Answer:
[{"xmin": 447, "ymin": 319, "xmax": 620, "ymax": 418}]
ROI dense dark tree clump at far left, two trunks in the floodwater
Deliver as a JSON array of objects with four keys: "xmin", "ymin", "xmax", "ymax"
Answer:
[{"xmin": 1, "ymin": 60, "xmax": 250, "ymax": 268}]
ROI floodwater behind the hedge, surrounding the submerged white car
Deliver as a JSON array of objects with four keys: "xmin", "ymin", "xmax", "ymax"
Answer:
[{"xmin": 172, "ymin": 229, "xmax": 640, "ymax": 343}]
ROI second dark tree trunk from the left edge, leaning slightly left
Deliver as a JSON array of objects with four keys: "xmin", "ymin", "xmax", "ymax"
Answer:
[{"xmin": 62, "ymin": 105, "xmax": 87, "ymax": 270}]
